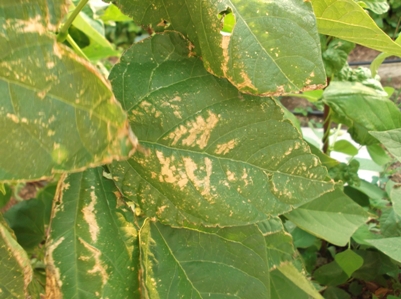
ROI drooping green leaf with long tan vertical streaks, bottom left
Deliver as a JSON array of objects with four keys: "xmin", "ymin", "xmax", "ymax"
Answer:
[{"xmin": 46, "ymin": 168, "xmax": 139, "ymax": 298}]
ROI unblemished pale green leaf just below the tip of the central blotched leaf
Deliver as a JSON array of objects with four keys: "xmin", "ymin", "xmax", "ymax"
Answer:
[{"xmin": 285, "ymin": 189, "xmax": 368, "ymax": 246}]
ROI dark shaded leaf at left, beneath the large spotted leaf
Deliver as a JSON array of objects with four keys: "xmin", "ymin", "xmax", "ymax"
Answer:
[{"xmin": 4, "ymin": 185, "xmax": 56, "ymax": 249}]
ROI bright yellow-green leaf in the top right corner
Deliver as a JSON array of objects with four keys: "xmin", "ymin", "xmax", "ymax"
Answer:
[{"xmin": 312, "ymin": 0, "xmax": 401, "ymax": 56}]
